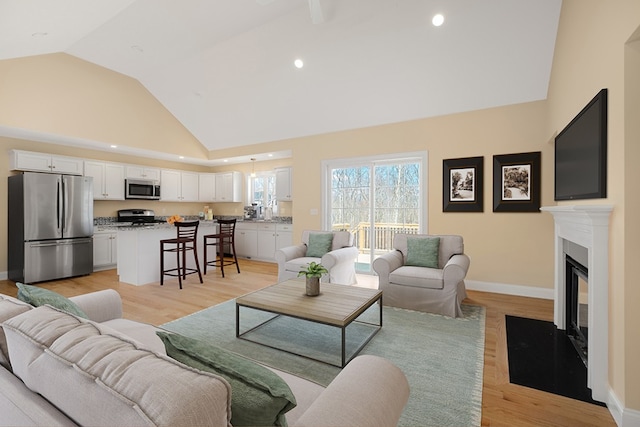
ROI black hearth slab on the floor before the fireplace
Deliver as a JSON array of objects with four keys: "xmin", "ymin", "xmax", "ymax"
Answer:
[{"xmin": 506, "ymin": 316, "xmax": 606, "ymax": 406}]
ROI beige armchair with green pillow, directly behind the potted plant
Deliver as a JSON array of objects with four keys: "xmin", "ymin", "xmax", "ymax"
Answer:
[{"xmin": 275, "ymin": 230, "xmax": 358, "ymax": 285}]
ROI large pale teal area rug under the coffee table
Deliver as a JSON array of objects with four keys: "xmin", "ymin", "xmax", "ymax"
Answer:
[{"xmin": 161, "ymin": 300, "xmax": 485, "ymax": 427}]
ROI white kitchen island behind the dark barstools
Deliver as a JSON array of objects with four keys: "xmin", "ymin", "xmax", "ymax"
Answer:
[{"xmin": 110, "ymin": 221, "xmax": 218, "ymax": 285}]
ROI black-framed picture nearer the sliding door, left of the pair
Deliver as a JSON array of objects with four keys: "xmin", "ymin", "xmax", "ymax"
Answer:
[{"xmin": 442, "ymin": 157, "xmax": 484, "ymax": 212}]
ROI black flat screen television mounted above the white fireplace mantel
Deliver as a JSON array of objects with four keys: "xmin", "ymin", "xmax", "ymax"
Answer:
[{"xmin": 555, "ymin": 89, "xmax": 607, "ymax": 200}]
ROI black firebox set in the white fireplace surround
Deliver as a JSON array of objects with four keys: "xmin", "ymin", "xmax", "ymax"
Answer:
[{"xmin": 565, "ymin": 255, "xmax": 589, "ymax": 366}]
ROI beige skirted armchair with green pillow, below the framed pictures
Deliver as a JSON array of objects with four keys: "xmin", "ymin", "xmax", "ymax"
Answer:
[{"xmin": 373, "ymin": 234, "xmax": 470, "ymax": 317}]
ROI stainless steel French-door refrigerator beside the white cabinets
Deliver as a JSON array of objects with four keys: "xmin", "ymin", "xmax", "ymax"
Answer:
[{"xmin": 7, "ymin": 172, "xmax": 93, "ymax": 283}]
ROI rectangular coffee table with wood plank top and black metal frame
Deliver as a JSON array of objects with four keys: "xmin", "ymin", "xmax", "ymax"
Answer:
[{"xmin": 236, "ymin": 280, "xmax": 382, "ymax": 367}]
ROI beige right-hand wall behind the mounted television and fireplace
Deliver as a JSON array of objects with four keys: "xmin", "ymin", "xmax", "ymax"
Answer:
[{"xmin": 548, "ymin": 0, "xmax": 640, "ymax": 410}]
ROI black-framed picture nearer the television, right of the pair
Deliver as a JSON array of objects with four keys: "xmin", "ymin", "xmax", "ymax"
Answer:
[{"xmin": 493, "ymin": 151, "xmax": 540, "ymax": 212}]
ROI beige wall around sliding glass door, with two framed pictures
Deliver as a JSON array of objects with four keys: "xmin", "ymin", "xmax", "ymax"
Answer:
[{"xmin": 212, "ymin": 101, "xmax": 553, "ymax": 288}]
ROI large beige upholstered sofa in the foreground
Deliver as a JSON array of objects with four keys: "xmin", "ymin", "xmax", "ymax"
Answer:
[{"xmin": 0, "ymin": 290, "xmax": 409, "ymax": 426}]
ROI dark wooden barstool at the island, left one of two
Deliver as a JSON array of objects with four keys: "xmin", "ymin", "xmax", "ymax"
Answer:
[{"xmin": 160, "ymin": 221, "xmax": 202, "ymax": 289}]
